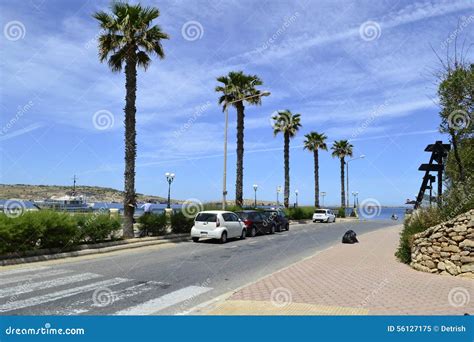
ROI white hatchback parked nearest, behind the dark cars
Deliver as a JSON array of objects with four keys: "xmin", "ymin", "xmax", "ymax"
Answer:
[{"xmin": 191, "ymin": 210, "xmax": 247, "ymax": 243}]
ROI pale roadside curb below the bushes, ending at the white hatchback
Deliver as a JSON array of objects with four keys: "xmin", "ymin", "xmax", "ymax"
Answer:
[{"xmin": 0, "ymin": 234, "xmax": 189, "ymax": 266}]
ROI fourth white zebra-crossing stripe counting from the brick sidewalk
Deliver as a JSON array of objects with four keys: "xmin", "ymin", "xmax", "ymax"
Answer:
[{"xmin": 0, "ymin": 273, "xmax": 100, "ymax": 298}]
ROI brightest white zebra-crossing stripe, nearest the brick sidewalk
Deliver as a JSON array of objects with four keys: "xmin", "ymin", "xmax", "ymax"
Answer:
[{"xmin": 115, "ymin": 286, "xmax": 212, "ymax": 316}]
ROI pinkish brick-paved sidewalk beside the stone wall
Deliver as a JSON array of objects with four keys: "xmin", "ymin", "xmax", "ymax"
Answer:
[{"xmin": 201, "ymin": 226, "xmax": 474, "ymax": 315}]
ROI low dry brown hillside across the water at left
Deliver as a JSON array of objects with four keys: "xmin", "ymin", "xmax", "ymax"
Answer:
[{"xmin": 0, "ymin": 184, "xmax": 169, "ymax": 203}]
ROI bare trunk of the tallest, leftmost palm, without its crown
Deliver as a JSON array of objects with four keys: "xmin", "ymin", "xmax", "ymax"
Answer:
[{"xmin": 123, "ymin": 56, "xmax": 137, "ymax": 238}]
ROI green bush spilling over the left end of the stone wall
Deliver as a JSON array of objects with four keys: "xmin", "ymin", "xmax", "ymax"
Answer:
[{"xmin": 395, "ymin": 208, "xmax": 443, "ymax": 264}]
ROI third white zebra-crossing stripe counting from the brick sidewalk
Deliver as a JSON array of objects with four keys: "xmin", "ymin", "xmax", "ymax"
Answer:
[{"xmin": 0, "ymin": 278, "xmax": 130, "ymax": 312}]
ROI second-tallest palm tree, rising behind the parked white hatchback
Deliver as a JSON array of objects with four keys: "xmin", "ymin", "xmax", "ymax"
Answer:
[{"xmin": 216, "ymin": 71, "xmax": 269, "ymax": 207}]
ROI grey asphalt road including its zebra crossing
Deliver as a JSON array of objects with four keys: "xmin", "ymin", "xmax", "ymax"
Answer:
[{"xmin": 0, "ymin": 221, "xmax": 399, "ymax": 315}]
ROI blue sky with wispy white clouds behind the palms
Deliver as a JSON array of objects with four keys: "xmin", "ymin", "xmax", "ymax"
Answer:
[{"xmin": 0, "ymin": 0, "xmax": 474, "ymax": 205}]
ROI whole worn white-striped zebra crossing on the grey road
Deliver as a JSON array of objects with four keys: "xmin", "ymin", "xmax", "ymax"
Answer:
[{"xmin": 0, "ymin": 266, "xmax": 212, "ymax": 315}]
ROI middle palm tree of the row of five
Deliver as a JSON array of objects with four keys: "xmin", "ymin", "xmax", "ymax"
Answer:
[{"xmin": 272, "ymin": 109, "xmax": 301, "ymax": 208}]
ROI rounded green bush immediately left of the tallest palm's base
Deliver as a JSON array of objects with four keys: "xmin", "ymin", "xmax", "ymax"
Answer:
[{"xmin": 76, "ymin": 212, "xmax": 121, "ymax": 243}]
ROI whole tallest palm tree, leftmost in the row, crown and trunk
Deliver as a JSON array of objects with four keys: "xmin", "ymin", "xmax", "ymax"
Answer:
[{"xmin": 93, "ymin": 2, "xmax": 169, "ymax": 237}]
